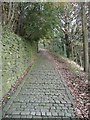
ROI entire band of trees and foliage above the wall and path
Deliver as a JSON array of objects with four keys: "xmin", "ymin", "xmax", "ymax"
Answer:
[{"xmin": 2, "ymin": 2, "xmax": 90, "ymax": 71}]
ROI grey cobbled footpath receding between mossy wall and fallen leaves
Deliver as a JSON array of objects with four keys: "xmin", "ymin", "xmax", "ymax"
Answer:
[{"xmin": 3, "ymin": 52, "xmax": 78, "ymax": 120}]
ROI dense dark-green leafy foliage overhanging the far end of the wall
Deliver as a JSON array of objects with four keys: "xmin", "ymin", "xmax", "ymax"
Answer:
[{"xmin": 24, "ymin": 3, "xmax": 56, "ymax": 41}]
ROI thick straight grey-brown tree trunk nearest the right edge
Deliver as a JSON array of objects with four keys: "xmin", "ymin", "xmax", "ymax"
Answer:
[{"xmin": 81, "ymin": 2, "xmax": 88, "ymax": 72}]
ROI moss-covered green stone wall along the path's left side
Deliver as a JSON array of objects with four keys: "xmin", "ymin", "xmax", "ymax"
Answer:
[{"xmin": 2, "ymin": 28, "xmax": 36, "ymax": 96}]
